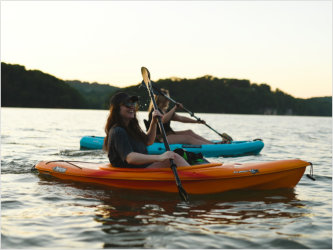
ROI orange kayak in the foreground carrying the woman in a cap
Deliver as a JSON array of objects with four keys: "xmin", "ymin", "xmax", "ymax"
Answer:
[{"xmin": 34, "ymin": 159, "xmax": 310, "ymax": 194}]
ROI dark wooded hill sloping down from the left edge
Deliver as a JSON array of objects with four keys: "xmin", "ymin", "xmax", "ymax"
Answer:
[{"xmin": 1, "ymin": 62, "xmax": 88, "ymax": 108}]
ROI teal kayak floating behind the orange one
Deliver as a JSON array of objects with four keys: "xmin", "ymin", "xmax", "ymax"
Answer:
[{"xmin": 80, "ymin": 136, "xmax": 264, "ymax": 157}]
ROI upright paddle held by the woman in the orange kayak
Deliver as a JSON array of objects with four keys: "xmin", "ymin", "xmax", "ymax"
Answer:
[{"xmin": 141, "ymin": 67, "xmax": 188, "ymax": 201}]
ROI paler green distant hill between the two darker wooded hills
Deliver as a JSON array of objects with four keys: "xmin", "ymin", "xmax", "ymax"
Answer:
[{"xmin": 66, "ymin": 80, "xmax": 119, "ymax": 109}]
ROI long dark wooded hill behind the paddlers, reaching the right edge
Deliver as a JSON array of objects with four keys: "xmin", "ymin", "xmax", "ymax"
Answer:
[{"xmin": 118, "ymin": 76, "xmax": 332, "ymax": 116}]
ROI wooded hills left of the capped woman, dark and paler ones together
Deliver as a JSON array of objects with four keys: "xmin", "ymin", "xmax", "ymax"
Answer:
[{"xmin": 1, "ymin": 62, "xmax": 119, "ymax": 109}]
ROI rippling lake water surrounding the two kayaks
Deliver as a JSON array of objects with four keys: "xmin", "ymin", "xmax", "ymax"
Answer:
[{"xmin": 1, "ymin": 108, "xmax": 332, "ymax": 249}]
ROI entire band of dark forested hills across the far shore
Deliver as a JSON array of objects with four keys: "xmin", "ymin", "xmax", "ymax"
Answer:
[{"xmin": 1, "ymin": 62, "xmax": 332, "ymax": 116}]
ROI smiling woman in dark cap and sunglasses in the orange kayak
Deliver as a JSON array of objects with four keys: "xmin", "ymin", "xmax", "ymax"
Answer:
[{"xmin": 103, "ymin": 92, "xmax": 189, "ymax": 168}]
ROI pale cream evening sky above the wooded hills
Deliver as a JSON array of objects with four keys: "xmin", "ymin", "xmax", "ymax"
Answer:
[{"xmin": 1, "ymin": 1, "xmax": 332, "ymax": 98}]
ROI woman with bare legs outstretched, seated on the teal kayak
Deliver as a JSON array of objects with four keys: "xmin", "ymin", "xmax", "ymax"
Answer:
[{"xmin": 148, "ymin": 89, "xmax": 230, "ymax": 145}]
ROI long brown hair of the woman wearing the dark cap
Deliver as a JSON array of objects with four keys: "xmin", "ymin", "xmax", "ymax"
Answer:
[{"xmin": 103, "ymin": 95, "xmax": 148, "ymax": 151}]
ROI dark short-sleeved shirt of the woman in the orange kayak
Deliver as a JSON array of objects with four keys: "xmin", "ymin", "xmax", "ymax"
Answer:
[{"xmin": 108, "ymin": 126, "xmax": 150, "ymax": 168}]
